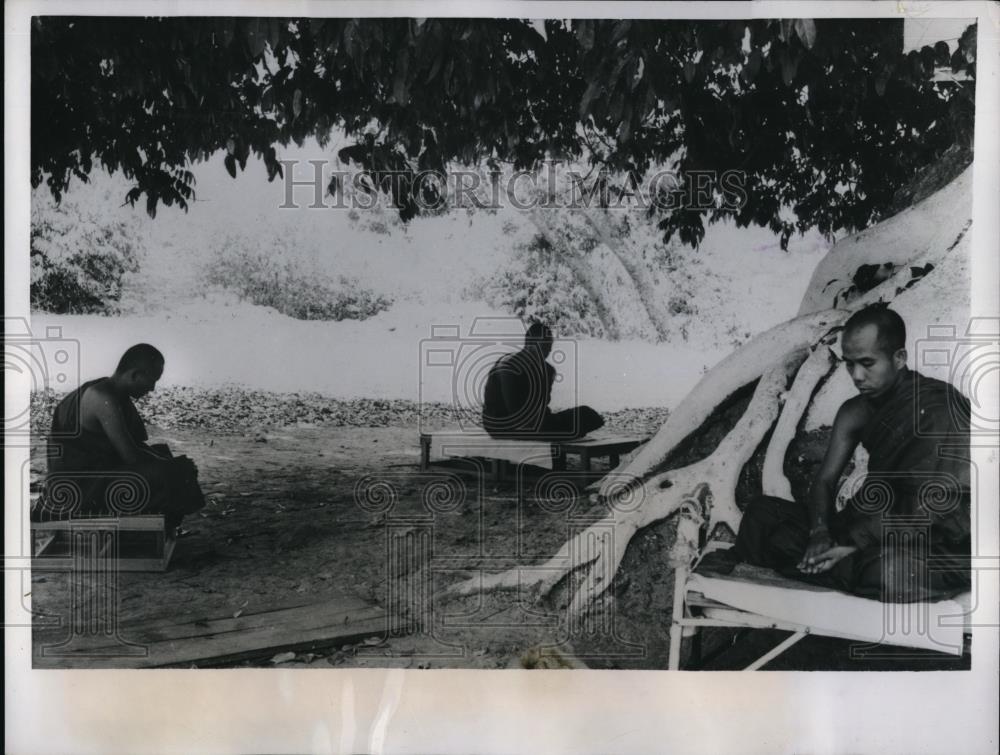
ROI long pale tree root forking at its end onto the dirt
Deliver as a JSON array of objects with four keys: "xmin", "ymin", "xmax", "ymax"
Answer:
[{"xmin": 449, "ymin": 349, "xmax": 809, "ymax": 613}]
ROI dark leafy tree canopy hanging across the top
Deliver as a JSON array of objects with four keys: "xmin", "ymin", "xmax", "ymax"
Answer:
[{"xmin": 31, "ymin": 16, "xmax": 975, "ymax": 243}]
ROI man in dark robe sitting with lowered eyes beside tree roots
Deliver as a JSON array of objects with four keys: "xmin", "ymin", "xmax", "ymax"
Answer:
[{"xmin": 732, "ymin": 306, "xmax": 971, "ymax": 602}]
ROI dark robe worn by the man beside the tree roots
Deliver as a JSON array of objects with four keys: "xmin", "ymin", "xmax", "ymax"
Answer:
[{"xmin": 732, "ymin": 370, "xmax": 971, "ymax": 602}]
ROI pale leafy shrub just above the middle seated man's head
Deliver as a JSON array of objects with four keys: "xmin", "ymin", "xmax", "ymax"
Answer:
[{"xmin": 467, "ymin": 236, "xmax": 604, "ymax": 337}]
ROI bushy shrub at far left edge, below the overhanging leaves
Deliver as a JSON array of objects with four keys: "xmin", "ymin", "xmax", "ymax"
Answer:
[{"xmin": 31, "ymin": 192, "xmax": 142, "ymax": 315}]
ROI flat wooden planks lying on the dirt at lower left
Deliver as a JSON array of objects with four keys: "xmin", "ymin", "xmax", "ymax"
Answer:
[{"xmin": 34, "ymin": 597, "xmax": 405, "ymax": 668}]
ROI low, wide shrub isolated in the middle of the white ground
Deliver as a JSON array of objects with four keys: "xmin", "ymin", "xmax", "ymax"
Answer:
[{"xmin": 205, "ymin": 236, "xmax": 392, "ymax": 320}]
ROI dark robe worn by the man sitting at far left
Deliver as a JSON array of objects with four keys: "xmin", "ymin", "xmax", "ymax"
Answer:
[{"xmin": 32, "ymin": 378, "xmax": 205, "ymax": 526}]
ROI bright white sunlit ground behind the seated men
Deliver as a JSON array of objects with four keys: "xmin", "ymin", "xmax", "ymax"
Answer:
[{"xmin": 32, "ymin": 153, "xmax": 828, "ymax": 410}]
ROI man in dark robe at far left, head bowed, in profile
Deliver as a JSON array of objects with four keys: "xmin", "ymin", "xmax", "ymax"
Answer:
[{"xmin": 32, "ymin": 344, "xmax": 205, "ymax": 531}]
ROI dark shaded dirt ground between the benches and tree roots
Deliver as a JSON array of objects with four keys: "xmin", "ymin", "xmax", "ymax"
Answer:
[{"xmin": 31, "ymin": 425, "xmax": 968, "ymax": 669}]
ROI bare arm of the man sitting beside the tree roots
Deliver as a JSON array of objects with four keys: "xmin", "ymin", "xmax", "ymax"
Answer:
[{"xmin": 799, "ymin": 397, "xmax": 870, "ymax": 571}]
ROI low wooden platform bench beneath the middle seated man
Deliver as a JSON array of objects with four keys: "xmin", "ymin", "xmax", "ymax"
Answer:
[{"xmin": 420, "ymin": 431, "xmax": 649, "ymax": 479}]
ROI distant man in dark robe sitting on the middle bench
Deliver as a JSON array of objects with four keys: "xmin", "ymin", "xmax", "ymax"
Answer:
[{"xmin": 483, "ymin": 323, "xmax": 604, "ymax": 441}]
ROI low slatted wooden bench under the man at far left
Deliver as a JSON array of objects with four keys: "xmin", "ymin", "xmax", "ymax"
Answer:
[{"xmin": 31, "ymin": 514, "xmax": 176, "ymax": 572}]
